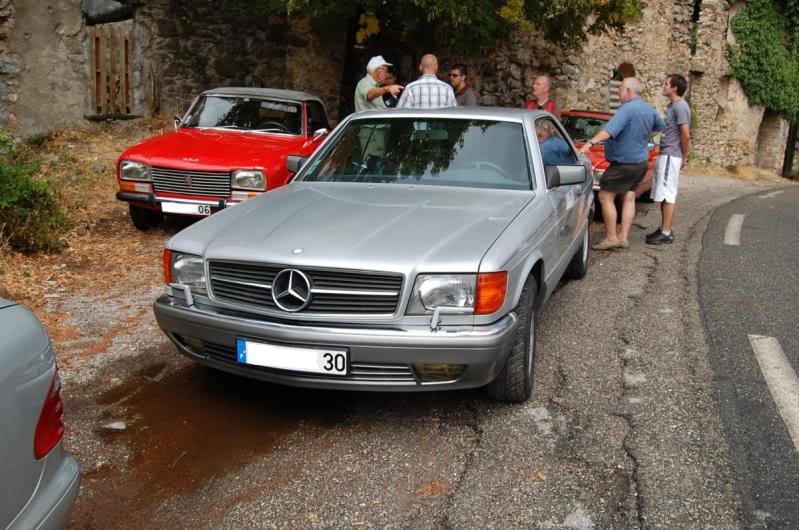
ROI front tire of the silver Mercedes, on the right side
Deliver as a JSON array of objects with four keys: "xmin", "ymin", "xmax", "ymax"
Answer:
[{"xmin": 486, "ymin": 276, "xmax": 538, "ymax": 403}]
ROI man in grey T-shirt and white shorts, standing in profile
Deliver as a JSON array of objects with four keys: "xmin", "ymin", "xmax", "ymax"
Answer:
[{"xmin": 646, "ymin": 74, "xmax": 691, "ymax": 245}]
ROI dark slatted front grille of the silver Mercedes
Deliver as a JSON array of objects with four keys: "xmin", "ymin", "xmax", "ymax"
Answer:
[{"xmin": 209, "ymin": 261, "xmax": 403, "ymax": 315}]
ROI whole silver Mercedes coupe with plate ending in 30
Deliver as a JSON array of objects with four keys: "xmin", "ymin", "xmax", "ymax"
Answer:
[{"xmin": 154, "ymin": 108, "xmax": 593, "ymax": 402}]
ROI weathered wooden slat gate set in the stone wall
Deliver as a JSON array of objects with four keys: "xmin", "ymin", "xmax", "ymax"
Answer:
[{"xmin": 89, "ymin": 22, "xmax": 133, "ymax": 117}]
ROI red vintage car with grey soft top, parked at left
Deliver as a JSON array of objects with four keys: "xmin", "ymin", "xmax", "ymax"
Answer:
[{"xmin": 116, "ymin": 87, "xmax": 330, "ymax": 230}]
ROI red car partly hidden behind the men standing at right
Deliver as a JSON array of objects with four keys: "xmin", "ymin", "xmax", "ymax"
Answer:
[{"xmin": 560, "ymin": 110, "xmax": 660, "ymax": 199}]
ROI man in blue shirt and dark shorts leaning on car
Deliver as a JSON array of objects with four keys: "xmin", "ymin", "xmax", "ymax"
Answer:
[{"xmin": 580, "ymin": 77, "xmax": 666, "ymax": 250}]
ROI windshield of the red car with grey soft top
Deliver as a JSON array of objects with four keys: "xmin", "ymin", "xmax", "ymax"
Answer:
[{"xmin": 182, "ymin": 96, "xmax": 302, "ymax": 135}]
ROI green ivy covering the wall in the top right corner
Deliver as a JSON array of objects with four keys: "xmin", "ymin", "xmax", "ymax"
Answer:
[{"xmin": 730, "ymin": 0, "xmax": 799, "ymax": 121}]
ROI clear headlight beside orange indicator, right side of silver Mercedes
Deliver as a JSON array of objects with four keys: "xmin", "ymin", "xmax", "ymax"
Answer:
[{"xmin": 408, "ymin": 274, "xmax": 477, "ymax": 315}]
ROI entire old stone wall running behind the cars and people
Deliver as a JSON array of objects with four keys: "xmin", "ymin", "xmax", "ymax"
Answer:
[{"xmin": 0, "ymin": 0, "xmax": 787, "ymax": 169}]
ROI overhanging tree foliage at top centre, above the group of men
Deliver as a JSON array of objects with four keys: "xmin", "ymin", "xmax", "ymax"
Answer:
[{"xmin": 240, "ymin": 0, "xmax": 645, "ymax": 51}]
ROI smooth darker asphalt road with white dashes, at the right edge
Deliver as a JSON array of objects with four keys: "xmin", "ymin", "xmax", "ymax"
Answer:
[{"xmin": 699, "ymin": 186, "xmax": 799, "ymax": 528}]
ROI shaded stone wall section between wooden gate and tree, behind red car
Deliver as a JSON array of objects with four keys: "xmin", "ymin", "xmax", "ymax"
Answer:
[{"xmin": 134, "ymin": 0, "xmax": 344, "ymax": 119}]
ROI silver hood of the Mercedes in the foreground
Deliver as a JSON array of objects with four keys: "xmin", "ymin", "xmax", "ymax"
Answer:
[{"xmin": 178, "ymin": 182, "xmax": 533, "ymax": 273}]
